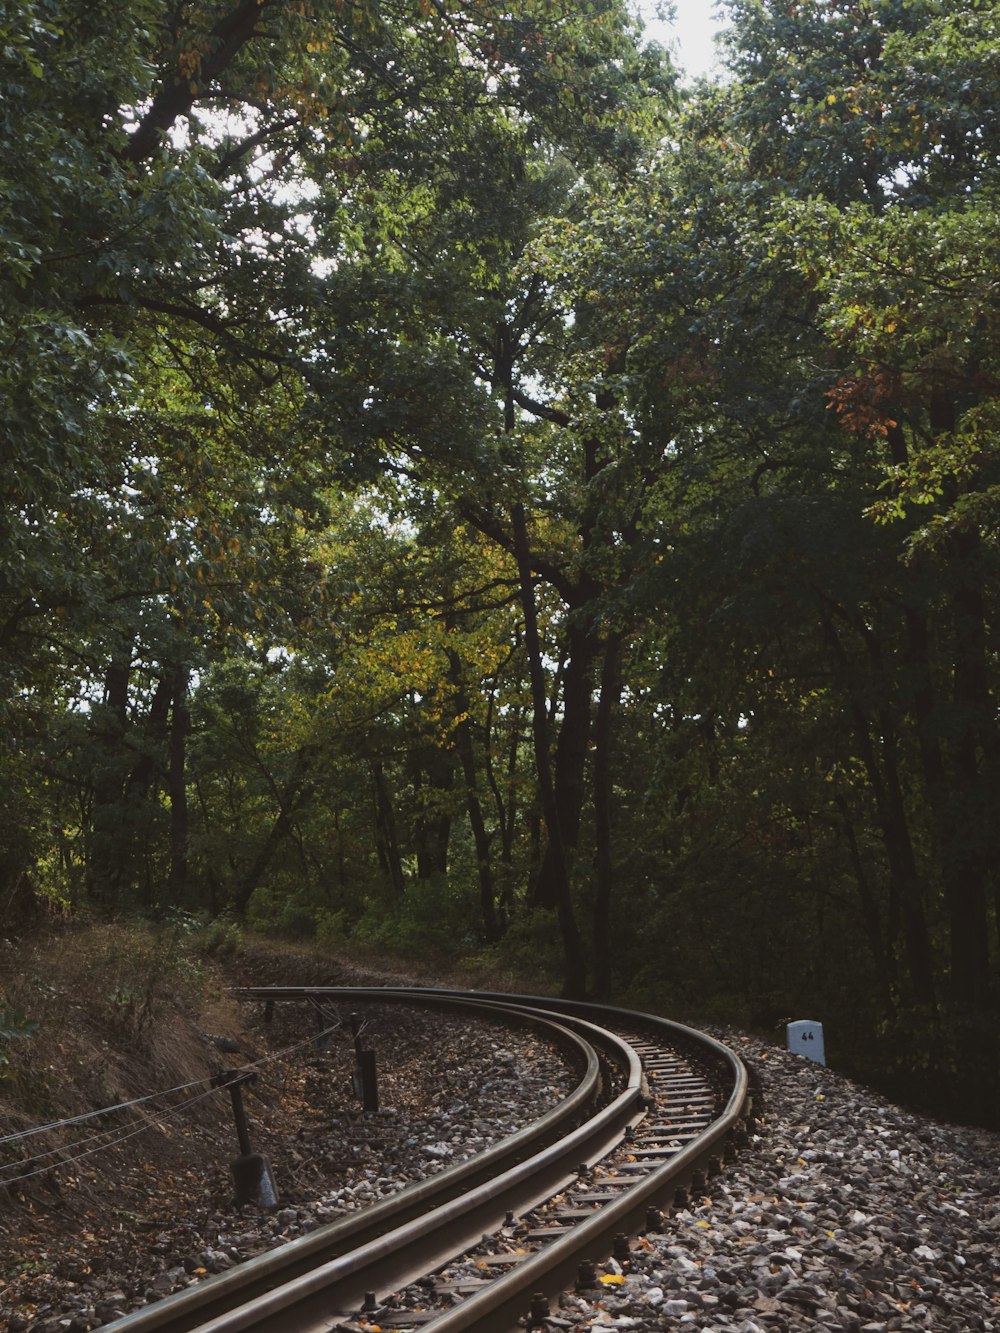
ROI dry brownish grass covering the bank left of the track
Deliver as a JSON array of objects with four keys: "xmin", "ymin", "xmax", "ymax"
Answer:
[{"xmin": 0, "ymin": 922, "xmax": 549, "ymax": 1234}]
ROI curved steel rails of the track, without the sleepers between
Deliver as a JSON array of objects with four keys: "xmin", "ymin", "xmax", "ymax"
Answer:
[{"xmin": 108, "ymin": 986, "xmax": 747, "ymax": 1333}]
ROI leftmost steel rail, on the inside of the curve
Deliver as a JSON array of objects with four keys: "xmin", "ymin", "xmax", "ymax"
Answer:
[{"xmin": 105, "ymin": 990, "xmax": 601, "ymax": 1333}]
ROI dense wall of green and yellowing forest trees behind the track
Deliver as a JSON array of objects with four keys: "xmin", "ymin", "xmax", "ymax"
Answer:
[{"xmin": 0, "ymin": 0, "xmax": 1000, "ymax": 1117}]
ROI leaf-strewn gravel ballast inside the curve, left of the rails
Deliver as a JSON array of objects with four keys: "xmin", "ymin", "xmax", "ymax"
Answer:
[{"xmin": 0, "ymin": 1004, "xmax": 579, "ymax": 1333}]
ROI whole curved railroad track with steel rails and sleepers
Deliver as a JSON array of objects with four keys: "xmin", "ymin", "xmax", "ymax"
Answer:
[{"xmin": 105, "ymin": 986, "xmax": 749, "ymax": 1333}]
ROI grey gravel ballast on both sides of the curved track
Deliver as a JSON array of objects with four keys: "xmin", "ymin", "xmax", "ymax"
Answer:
[{"xmin": 0, "ymin": 1006, "xmax": 1000, "ymax": 1333}]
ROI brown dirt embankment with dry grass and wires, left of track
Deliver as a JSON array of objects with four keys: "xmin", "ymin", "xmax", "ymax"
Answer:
[{"xmin": 0, "ymin": 924, "xmax": 533, "ymax": 1247}]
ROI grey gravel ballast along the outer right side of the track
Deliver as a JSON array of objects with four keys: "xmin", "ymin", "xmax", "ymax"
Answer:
[{"xmin": 552, "ymin": 1032, "xmax": 1000, "ymax": 1333}]
